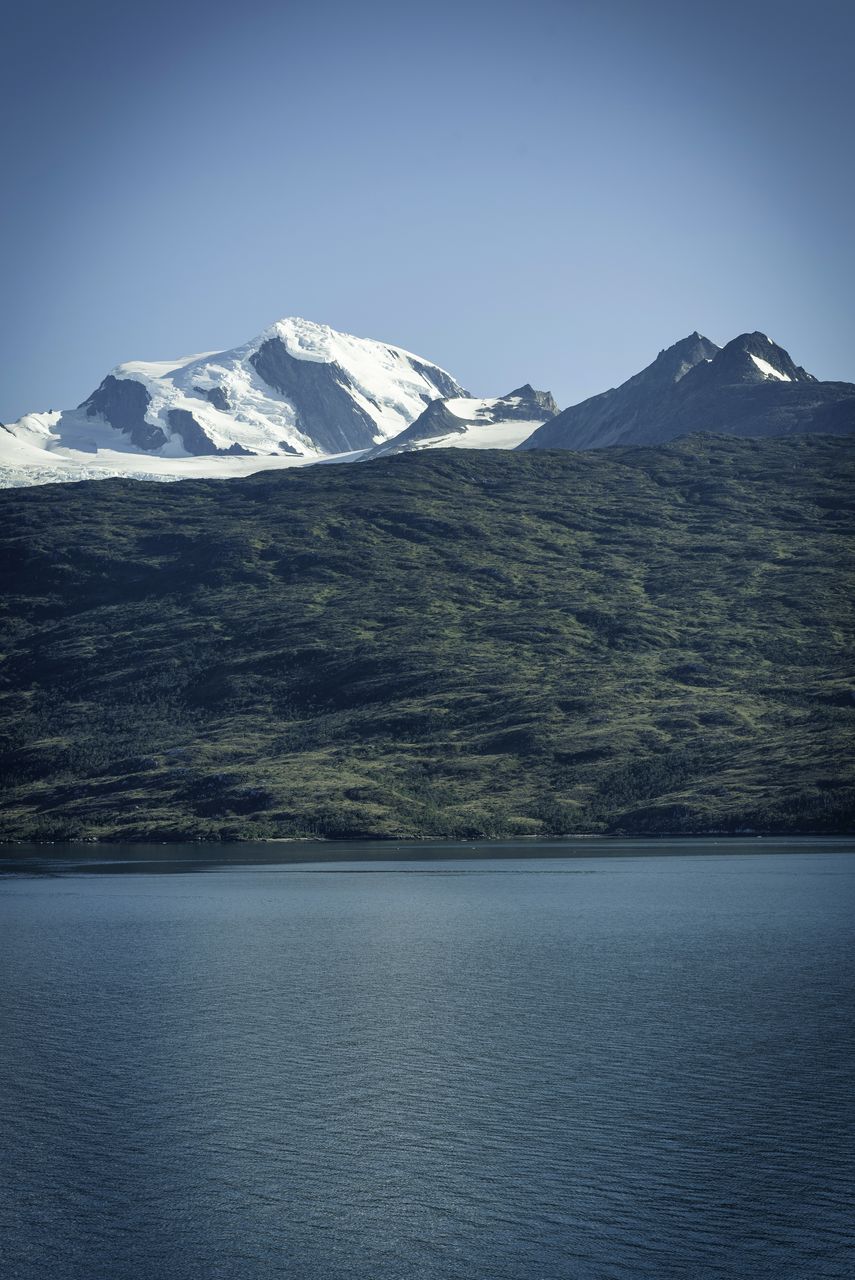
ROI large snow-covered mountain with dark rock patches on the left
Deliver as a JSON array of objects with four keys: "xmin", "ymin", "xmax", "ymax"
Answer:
[{"xmin": 0, "ymin": 319, "xmax": 467, "ymax": 479}]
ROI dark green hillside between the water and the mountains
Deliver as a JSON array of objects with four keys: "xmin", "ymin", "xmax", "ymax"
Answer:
[{"xmin": 0, "ymin": 436, "xmax": 855, "ymax": 838}]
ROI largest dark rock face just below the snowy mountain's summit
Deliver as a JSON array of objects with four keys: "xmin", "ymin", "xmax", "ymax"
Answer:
[{"xmin": 250, "ymin": 338, "xmax": 376, "ymax": 453}]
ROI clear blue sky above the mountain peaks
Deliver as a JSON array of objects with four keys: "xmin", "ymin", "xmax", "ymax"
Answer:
[{"xmin": 0, "ymin": 0, "xmax": 855, "ymax": 421}]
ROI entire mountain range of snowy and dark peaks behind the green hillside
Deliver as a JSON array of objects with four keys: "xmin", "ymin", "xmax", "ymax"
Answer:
[{"xmin": 0, "ymin": 317, "xmax": 855, "ymax": 486}]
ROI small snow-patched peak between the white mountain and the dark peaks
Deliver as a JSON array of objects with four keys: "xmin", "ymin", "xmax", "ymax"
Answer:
[{"xmin": 366, "ymin": 383, "xmax": 558, "ymax": 458}]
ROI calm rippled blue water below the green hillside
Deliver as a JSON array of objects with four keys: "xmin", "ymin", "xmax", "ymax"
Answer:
[{"xmin": 0, "ymin": 841, "xmax": 855, "ymax": 1280}]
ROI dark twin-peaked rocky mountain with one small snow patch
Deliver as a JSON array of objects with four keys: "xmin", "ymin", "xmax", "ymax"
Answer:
[{"xmin": 520, "ymin": 333, "xmax": 855, "ymax": 449}]
